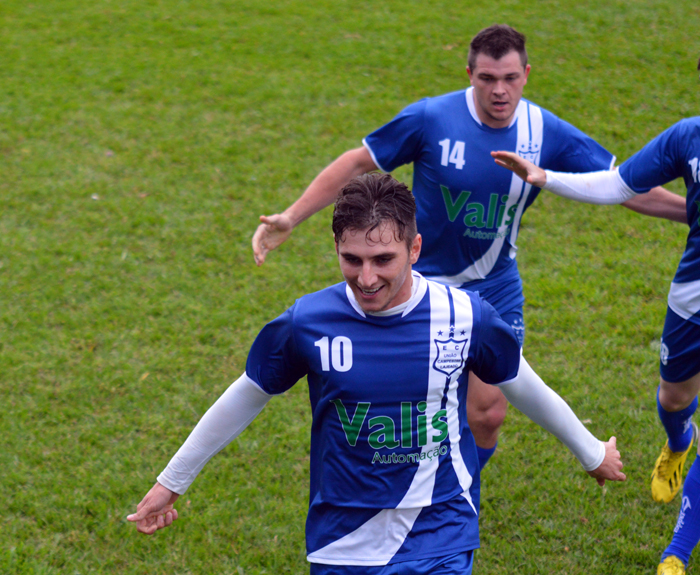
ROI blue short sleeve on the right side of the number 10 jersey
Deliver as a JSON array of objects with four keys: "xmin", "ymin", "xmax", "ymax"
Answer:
[{"xmin": 471, "ymin": 297, "xmax": 520, "ymax": 384}]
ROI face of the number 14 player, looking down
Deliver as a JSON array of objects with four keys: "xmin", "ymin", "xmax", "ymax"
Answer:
[{"xmin": 467, "ymin": 50, "xmax": 530, "ymax": 128}]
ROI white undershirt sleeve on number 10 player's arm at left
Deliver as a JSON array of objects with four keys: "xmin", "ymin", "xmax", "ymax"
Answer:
[{"xmin": 158, "ymin": 373, "xmax": 272, "ymax": 495}]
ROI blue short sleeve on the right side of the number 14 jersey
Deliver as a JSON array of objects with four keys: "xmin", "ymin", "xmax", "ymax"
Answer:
[{"xmin": 542, "ymin": 116, "xmax": 615, "ymax": 173}]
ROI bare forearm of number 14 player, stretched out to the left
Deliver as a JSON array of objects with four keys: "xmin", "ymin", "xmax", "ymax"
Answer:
[{"xmin": 284, "ymin": 147, "xmax": 377, "ymax": 227}]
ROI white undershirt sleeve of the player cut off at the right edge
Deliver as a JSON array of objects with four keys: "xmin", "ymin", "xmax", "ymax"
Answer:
[{"xmin": 544, "ymin": 170, "xmax": 637, "ymax": 204}]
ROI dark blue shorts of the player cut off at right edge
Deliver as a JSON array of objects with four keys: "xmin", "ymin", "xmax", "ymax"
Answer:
[{"xmin": 660, "ymin": 308, "xmax": 700, "ymax": 383}]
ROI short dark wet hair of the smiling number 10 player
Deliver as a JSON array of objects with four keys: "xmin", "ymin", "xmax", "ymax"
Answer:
[{"xmin": 333, "ymin": 172, "xmax": 418, "ymax": 250}]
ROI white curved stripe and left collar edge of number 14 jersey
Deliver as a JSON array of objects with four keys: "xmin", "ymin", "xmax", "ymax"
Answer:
[{"xmin": 429, "ymin": 88, "xmax": 544, "ymax": 286}]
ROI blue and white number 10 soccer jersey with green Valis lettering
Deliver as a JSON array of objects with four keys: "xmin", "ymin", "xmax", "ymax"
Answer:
[{"xmin": 246, "ymin": 272, "xmax": 520, "ymax": 566}]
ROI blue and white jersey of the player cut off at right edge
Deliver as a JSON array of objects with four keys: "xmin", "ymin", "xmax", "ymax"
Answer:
[{"xmin": 620, "ymin": 116, "xmax": 700, "ymax": 325}]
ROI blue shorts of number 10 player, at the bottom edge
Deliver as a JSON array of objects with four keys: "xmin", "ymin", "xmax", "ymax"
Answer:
[{"xmin": 311, "ymin": 551, "xmax": 474, "ymax": 575}]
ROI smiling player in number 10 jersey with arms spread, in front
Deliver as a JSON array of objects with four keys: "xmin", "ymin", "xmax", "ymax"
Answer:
[{"xmin": 128, "ymin": 174, "xmax": 625, "ymax": 575}]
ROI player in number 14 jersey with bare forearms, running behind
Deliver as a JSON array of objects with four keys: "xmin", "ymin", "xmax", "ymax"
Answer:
[{"xmin": 252, "ymin": 26, "xmax": 685, "ymax": 472}]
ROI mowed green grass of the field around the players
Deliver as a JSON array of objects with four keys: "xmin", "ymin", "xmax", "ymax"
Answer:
[{"xmin": 0, "ymin": 0, "xmax": 700, "ymax": 575}]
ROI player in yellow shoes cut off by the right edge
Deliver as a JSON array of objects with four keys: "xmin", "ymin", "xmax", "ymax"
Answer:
[{"xmin": 493, "ymin": 110, "xmax": 700, "ymax": 575}]
